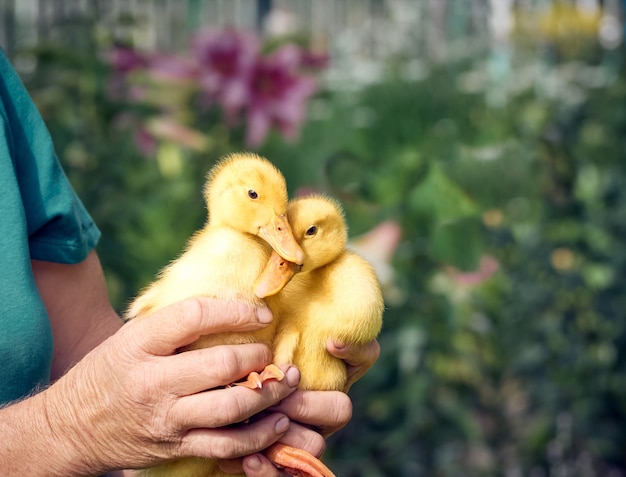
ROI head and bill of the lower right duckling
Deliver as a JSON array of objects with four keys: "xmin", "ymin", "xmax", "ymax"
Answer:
[{"xmin": 255, "ymin": 195, "xmax": 348, "ymax": 298}]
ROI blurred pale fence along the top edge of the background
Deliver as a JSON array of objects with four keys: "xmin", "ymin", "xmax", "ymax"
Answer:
[{"xmin": 0, "ymin": 0, "xmax": 626, "ymax": 96}]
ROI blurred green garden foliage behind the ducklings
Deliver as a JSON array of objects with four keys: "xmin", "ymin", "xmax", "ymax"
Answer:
[{"xmin": 13, "ymin": 9, "xmax": 626, "ymax": 477}]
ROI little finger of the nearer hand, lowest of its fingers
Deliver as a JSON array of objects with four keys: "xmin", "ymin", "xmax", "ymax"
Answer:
[{"xmin": 180, "ymin": 413, "xmax": 290, "ymax": 459}]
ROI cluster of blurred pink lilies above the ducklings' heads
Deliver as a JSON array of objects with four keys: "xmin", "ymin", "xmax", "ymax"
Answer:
[{"xmin": 109, "ymin": 29, "xmax": 327, "ymax": 150}]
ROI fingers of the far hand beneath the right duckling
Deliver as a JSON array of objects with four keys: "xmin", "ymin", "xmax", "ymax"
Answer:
[{"xmin": 220, "ymin": 390, "xmax": 352, "ymax": 477}]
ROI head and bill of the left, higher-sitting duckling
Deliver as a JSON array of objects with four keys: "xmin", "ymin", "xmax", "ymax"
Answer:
[{"xmin": 204, "ymin": 153, "xmax": 304, "ymax": 264}]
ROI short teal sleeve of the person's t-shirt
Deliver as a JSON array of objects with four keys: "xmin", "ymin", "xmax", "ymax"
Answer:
[{"xmin": 0, "ymin": 50, "xmax": 100, "ymax": 263}]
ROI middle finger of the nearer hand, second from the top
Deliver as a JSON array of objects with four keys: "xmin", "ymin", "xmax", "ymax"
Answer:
[{"xmin": 161, "ymin": 343, "xmax": 272, "ymax": 397}]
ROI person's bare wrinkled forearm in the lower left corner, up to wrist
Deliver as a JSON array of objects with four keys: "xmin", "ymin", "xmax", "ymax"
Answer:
[{"xmin": 0, "ymin": 351, "xmax": 141, "ymax": 477}]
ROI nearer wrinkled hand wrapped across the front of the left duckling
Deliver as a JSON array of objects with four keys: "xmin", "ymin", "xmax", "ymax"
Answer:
[{"xmin": 41, "ymin": 298, "xmax": 299, "ymax": 475}]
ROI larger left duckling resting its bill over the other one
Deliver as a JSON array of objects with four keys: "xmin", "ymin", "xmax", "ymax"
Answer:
[{"xmin": 126, "ymin": 154, "xmax": 304, "ymax": 477}]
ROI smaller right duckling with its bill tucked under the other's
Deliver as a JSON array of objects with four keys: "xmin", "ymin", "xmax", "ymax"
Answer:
[{"xmin": 257, "ymin": 195, "xmax": 384, "ymax": 477}]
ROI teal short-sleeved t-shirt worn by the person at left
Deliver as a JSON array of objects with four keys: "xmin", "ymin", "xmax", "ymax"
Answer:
[{"xmin": 0, "ymin": 50, "xmax": 100, "ymax": 403}]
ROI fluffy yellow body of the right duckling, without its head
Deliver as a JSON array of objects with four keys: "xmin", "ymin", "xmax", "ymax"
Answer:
[{"xmin": 272, "ymin": 249, "xmax": 383, "ymax": 391}]
